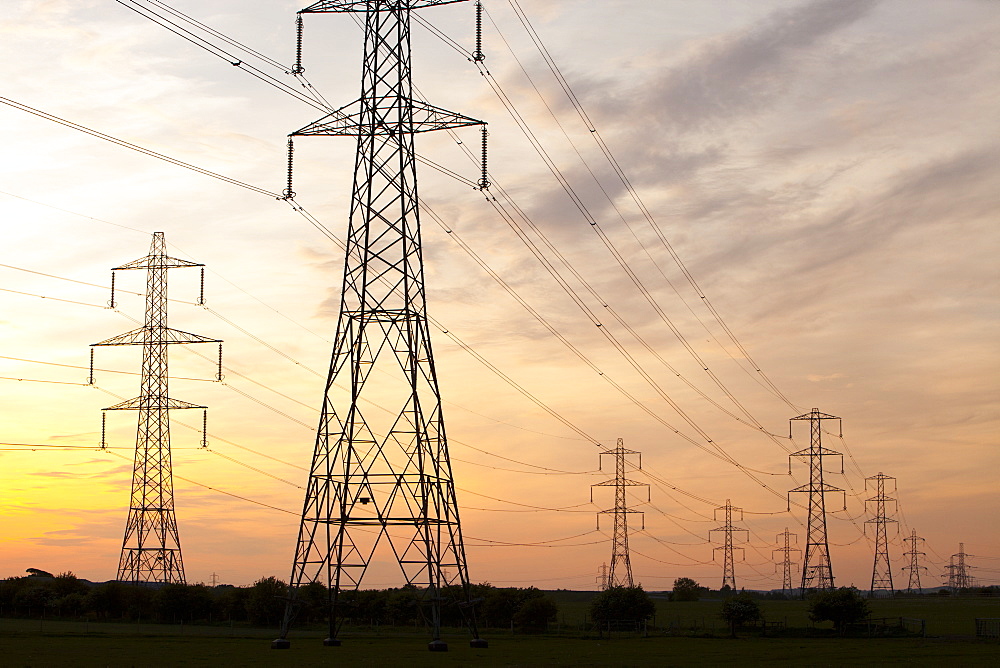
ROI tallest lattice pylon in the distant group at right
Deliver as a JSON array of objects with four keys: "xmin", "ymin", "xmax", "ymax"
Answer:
[{"xmin": 788, "ymin": 408, "xmax": 847, "ymax": 596}]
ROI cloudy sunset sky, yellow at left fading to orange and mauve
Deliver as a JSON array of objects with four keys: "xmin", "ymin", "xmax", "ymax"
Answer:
[{"xmin": 0, "ymin": 0, "xmax": 1000, "ymax": 590}]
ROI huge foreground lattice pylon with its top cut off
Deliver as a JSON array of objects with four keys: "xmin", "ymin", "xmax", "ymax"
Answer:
[{"xmin": 272, "ymin": 0, "xmax": 487, "ymax": 651}]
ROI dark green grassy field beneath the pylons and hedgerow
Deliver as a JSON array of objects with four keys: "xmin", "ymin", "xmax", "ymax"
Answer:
[{"xmin": 0, "ymin": 592, "xmax": 1000, "ymax": 667}]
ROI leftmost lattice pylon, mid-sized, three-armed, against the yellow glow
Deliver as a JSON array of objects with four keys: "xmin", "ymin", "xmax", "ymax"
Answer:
[{"xmin": 90, "ymin": 232, "xmax": 222, "ymax": 584}]
